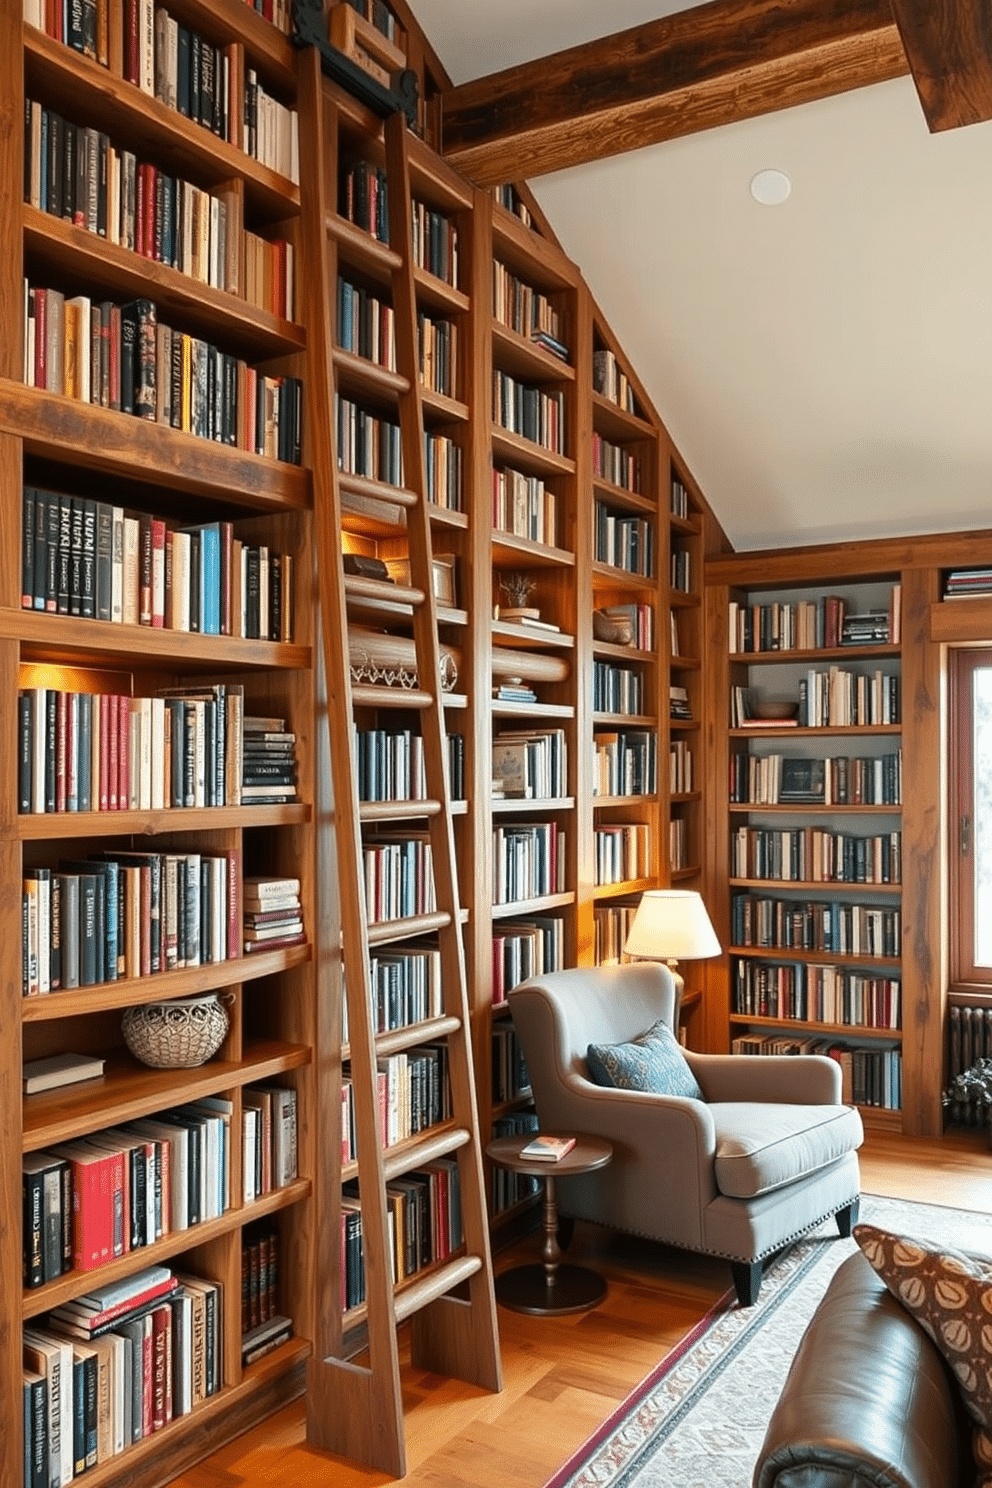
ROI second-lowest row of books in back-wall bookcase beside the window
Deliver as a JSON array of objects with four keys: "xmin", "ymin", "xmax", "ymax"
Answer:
[{"xmin": 732, "ymin": 957, "xmax": 901, "ymax": 1028}]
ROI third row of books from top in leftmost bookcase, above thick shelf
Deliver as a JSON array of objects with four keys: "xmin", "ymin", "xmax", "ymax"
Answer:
[{"xmin": 24, "ymin": 280, "xmax": 303, "ymax": 464}]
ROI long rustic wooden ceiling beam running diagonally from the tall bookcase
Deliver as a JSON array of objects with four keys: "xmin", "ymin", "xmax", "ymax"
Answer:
[{"xmin": 442, "ymin": 0, "xmax": 910, "ymax": 186}]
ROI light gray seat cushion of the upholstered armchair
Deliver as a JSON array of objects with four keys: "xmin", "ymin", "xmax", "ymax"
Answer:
[{"xmin": 709, "ymin": 1101, "xmax": 863, "ymax": 1199}]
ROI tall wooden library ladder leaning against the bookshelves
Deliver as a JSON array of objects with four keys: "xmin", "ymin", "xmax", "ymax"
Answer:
[{"xmin": 292, "ymin": 49, "xmax": 501, "ymax": 1476}]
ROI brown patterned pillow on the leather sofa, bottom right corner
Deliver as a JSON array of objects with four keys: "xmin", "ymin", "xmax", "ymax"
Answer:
[{"xmin": 852, "ymin": 1225, "xmax": 992, "ymax": 1488}]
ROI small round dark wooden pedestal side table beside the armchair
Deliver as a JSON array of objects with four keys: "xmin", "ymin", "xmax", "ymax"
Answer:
[{"xmin": 486, "ymin": 1132, "xmax": 613, "ymax": 1314}]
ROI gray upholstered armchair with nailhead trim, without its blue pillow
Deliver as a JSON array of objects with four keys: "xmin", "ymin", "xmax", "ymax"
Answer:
[{"xmin": 510, "ymin": 961, "xmax": 864, "ymax": 1306}]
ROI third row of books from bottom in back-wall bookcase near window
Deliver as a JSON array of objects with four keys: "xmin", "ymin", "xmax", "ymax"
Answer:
[{"xmin": 730, "ymin": 894, "xmax": 903, "ymax": 957}]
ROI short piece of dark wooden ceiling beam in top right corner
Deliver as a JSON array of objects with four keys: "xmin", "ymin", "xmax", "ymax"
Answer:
[{"xmin": 891, "ymin": 0, "xmax": 992, "ymax": 134}]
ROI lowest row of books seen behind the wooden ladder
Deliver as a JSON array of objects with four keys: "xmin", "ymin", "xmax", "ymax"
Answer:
[{"xmin": 341, "ymin": 1158, "xmax": 463, "ymax": 1311}]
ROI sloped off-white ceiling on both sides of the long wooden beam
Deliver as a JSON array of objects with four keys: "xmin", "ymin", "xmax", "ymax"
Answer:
[{"xmin": 412, "ymin": 0, "xmax": 992, "ymax": 549}]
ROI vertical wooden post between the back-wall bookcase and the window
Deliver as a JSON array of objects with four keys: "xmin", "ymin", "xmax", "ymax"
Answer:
[{"xmin": 903, "ymin": 568, "xmax": 947, "ymax": 1137}]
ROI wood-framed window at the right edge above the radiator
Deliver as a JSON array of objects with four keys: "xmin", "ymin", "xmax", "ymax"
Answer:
[{"xmin": 950, "ymin": 649, "xmax": 992, "ymax": 991}]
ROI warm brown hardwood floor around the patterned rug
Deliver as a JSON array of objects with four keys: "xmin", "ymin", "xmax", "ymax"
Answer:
[{"xmin": 173, "ymin": 1134, "xmax": 992, "ymax": 1488}]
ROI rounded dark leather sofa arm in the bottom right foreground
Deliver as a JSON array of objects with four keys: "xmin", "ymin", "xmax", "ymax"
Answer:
[{"xmin": 753, "ymin": 1251, "xmax": 974, "ymax": 1488}]
